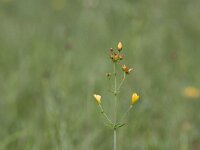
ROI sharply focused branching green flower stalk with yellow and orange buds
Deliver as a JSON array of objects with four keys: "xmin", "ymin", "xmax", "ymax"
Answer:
[{"xmin": 94, "ymin": 42, "xmax": 140, "ymax": 150}]
